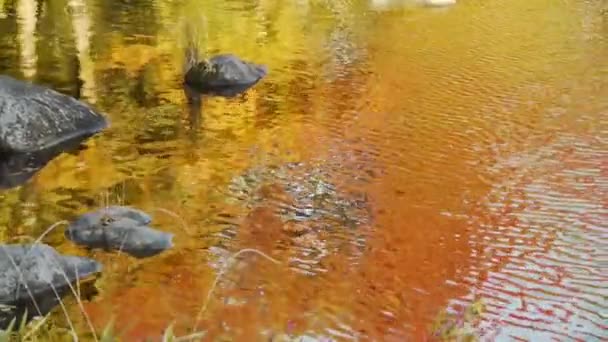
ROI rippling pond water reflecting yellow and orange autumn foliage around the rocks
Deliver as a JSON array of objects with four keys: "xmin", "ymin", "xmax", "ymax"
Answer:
[{"xmin": 0, "ymin": 0, "xmax": 608, "ymax": 341}]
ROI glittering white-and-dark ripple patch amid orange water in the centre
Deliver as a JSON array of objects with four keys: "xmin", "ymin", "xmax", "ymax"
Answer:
[{"xmin": 209, "ymin": 163, "xmax": 371, "ymax": 274}]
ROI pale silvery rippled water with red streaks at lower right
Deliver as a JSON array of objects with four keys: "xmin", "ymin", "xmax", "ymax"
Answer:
[{"xmin": 446, "ymin": 136, "xmax": 608, "ymax": 341}]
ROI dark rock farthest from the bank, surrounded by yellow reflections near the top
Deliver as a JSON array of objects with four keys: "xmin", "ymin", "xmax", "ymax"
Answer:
[{"xmin": 185, "ymin": 54, "xmax": 268, "ymax": 96}]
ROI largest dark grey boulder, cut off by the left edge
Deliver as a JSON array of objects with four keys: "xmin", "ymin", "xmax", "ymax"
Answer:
[{"xmin": 0, "ymin": 75, "xmax": 108, "ymax": 154}]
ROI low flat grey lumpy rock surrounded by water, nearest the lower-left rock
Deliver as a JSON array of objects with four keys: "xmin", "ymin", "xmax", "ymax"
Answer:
[{"xmin": 65, "ymin": 206, "xmax": 173, "ymax": 258}]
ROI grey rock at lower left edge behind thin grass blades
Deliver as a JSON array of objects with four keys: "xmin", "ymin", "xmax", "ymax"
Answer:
[{"xmin": 0, "ymin": 244, "xmax": 102, "ymax": 329}]
